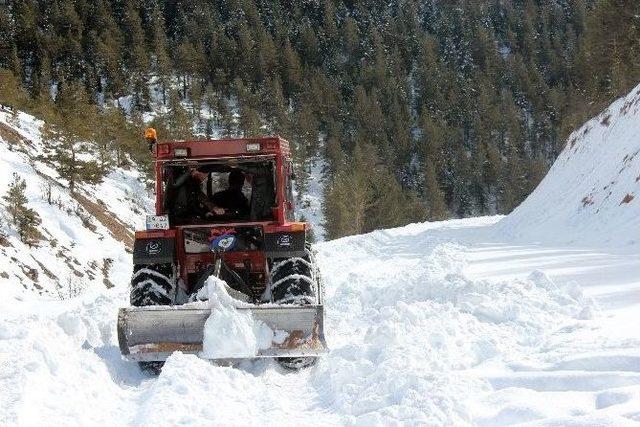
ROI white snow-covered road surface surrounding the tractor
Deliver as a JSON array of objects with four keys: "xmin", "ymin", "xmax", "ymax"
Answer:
[{"xmin": 0, "ymin": 217, "xmax": 640, "ymax": 426}]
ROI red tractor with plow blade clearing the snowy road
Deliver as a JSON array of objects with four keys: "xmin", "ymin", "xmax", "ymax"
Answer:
[{"xmin": 118, "ymin": 137, "xmax": 326, "ymax": 368}]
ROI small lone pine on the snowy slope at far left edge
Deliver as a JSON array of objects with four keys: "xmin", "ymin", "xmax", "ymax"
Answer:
[{"xmin": 3, "ymin": 172, "xmax": 42, "ymax": 245}]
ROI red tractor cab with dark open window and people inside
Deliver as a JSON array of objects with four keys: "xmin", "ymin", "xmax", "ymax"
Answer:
[{"xmin": 156, "ymin": 138, "xmax": 294, "ymax": 225}]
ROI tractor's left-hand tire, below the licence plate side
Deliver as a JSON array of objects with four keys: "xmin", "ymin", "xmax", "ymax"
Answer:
[{"xmin": 129, "ymin": 264, "xmax": 176, "ymax": 375}]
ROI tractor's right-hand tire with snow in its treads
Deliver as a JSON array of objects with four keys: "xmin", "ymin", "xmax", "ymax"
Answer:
[{"xmin": 271, "ymin": 247, "xmax": 318, "ymax": 371}]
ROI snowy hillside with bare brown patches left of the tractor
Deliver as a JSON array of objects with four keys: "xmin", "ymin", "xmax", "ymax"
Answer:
[{"xmin": 0, "ymin": 110, "xmax": 151, "ymax": 298}]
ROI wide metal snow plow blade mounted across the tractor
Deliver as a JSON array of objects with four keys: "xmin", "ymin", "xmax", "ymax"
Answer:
[{"xmin": 118, "ymin": 305, "xmax": 327, "ymax": 362}]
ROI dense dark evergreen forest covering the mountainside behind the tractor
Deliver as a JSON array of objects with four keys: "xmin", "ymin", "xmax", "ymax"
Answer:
[{"xmin": 0, "ymin": 0, "xmax": 640, "ymax": 238}]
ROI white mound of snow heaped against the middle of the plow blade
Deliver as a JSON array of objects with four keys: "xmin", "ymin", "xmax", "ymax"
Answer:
[{"xmin": 200, "ymin": 276, "xmax": 274, "ymax": 359}]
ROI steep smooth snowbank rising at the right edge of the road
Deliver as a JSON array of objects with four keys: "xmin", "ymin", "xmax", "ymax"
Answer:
[{"xmin": 498, "ymin": 86, "xmax": 640, "ymax": 246}]
